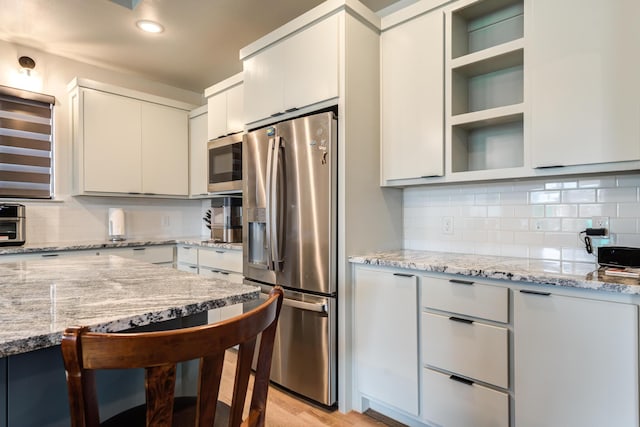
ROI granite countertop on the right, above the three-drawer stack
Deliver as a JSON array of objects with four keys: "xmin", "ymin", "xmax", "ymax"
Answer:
[{"xmin": 349, "ymin": 250, "xmax": 640, "ymax": 295}]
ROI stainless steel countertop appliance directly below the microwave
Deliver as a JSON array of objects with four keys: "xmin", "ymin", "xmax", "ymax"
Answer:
[{"xmin": 204, "ymin": 196, "xmax": 242, "ymax": 243}]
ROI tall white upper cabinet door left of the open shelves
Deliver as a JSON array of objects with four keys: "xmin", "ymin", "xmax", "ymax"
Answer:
[{"xmin": 381, "ymin": 11, "xmax": 444, "ymax": 184}]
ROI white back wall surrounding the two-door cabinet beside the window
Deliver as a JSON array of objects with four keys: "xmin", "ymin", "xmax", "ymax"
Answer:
[{"xmin": 0, "ymin": 41, "xmax": 204, "ymax": 244}]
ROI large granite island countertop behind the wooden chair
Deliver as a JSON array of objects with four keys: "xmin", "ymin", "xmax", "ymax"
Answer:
[{"xmin": 0, "ymin": 255, "xmax": 259, "ymax": 357}]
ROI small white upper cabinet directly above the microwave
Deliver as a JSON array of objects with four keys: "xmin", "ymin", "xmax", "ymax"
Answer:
[{"xmin": 204, "ymin": 73, "xmax": 244, "ymax": 140}]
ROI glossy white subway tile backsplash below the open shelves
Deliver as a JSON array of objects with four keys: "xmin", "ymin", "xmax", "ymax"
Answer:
[{"xmin": 403, "ymin": 174, "xmax": 640, "ymax": 262}]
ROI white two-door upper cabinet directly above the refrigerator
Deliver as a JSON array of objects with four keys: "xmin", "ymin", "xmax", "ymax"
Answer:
[{"xmin": 243, "ymin": 14, "xmax": 339, "ymax": 123}]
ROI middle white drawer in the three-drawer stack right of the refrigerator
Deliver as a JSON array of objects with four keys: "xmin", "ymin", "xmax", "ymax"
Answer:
[{"xmin": 422, "ymin": 313, "xmax": 509, "ymax": 388}]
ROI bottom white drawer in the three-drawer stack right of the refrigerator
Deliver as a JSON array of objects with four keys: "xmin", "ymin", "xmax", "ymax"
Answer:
[{"xmin": 422, "ymin": 368, "xmax": 509, "ymax": 427}]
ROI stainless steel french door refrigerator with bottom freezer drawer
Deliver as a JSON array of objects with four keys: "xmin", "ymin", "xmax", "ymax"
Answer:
[{"xmin": 242, "ymin": 111, "xmax": 337, "ymax": 406}]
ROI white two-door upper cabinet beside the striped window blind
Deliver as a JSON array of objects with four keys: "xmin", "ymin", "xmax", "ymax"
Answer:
[{"xmin": 69, "ymin": 79, "xmax": 191, "ymax": 196}]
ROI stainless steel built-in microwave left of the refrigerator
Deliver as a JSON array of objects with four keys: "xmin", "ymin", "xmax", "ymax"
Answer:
[{"xmin": 207, "ymin": 132, "xmax": 242, "ymax": 193}]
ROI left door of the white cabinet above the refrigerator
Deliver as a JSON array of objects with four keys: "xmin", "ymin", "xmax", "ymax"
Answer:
[{"xmin": 243, "ymin": 42, "xmax": 284, "ymax": 123}]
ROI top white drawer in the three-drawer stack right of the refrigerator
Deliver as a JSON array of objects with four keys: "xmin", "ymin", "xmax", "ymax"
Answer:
[{"xmin": 421, "ymin": 276, "xmax": 509, "ymax": 323}]
